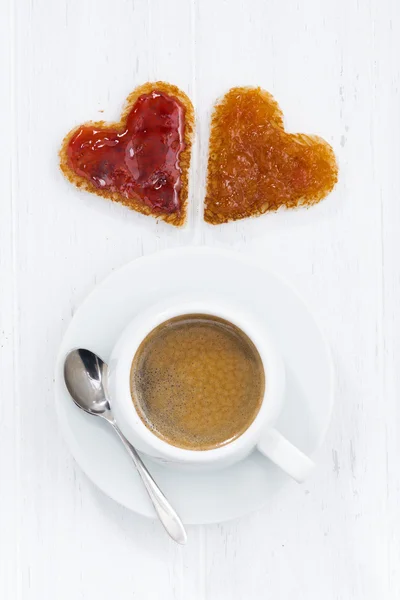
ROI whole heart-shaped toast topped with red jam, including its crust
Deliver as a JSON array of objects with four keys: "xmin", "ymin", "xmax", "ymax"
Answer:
[{"xmin": 60, "ymin": 81, "xmax": 194, "ymax": 226}]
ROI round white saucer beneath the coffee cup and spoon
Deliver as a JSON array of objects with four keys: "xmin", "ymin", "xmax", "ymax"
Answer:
[{"xmin": 55, "ymin": 248, "xmax": 333, "ymax": 524}]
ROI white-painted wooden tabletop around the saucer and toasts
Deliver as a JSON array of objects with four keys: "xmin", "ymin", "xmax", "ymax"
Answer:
[{"xmin": 0, "ymin": 0, "xmax": 400, "ymax": 600}]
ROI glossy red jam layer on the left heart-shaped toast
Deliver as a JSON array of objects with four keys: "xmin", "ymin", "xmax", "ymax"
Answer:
[{"xmin": 67, "ymin": 91, "xmax": 185, "ymax": 215}]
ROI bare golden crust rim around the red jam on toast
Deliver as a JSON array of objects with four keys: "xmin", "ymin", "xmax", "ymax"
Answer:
[{"xmin": 59, "ymin": 81, "xmax": 194, "ymax": 227}]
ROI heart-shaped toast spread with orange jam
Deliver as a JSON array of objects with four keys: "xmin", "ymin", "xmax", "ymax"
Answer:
[{"xmin": 204, "ymin": 87, "xmax": 338, "ymax": 225}]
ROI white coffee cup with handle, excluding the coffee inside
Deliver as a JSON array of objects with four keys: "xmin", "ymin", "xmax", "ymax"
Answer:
[{"xmin": 107, "ymin": 297, "xmax": 314, "ymax": 482}]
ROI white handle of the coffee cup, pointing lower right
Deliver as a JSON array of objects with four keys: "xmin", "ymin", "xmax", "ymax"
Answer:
[{"xmin": 257, "ymin": 429, "xmax": 315, "ymax": 483}]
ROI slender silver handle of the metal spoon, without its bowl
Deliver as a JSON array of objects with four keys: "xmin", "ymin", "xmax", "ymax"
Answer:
[{"xmin": 111, "ymin": 422, "xmax": 187, "ymax": 544}]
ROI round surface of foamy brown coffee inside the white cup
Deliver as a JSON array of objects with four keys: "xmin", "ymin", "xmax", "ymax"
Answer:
[{"xmin": 130, "ymin": 314, "xmax": 265, "ymax": 450}]
